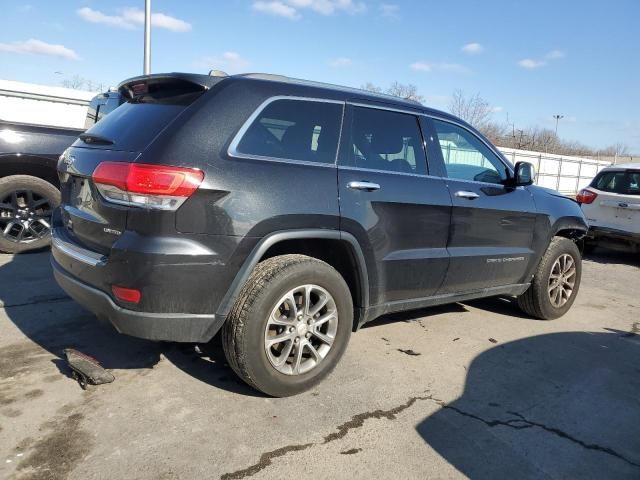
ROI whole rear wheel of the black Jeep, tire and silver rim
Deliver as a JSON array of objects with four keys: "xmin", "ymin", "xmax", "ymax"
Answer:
[{"xmin": 222, "ymin": 255, "xmax": 353, "ymax": 397}]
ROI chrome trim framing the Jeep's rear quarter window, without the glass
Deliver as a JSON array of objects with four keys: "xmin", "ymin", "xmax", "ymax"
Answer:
[{"xmin": 227, "ymin": 95, "xmax": 345, "ymax": 168}]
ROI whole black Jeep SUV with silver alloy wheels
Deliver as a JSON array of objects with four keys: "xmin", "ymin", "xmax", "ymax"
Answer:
[{"xmin": 52, "ymin": 73, "xmax": 587, "ymax": 396}]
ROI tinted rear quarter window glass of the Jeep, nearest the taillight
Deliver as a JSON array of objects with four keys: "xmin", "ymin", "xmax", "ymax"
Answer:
[{"xmin": 235, "ymin": 100, "xmax": 343, "ymax": 163}]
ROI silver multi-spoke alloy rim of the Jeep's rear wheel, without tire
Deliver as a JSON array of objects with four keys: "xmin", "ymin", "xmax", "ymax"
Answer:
[{"xmin": 264, "ymin": 284, "xmax": 338, "ymax": 375}]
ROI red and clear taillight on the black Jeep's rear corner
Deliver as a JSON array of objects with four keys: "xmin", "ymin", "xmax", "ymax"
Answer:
[{"xmin": 92, "ymin": 162, "xmax": 204, "ymax": 210}]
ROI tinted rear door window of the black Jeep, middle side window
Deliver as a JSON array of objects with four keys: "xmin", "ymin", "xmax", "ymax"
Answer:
[{"xmin": 341, "ymin": 107, "xmax": 427, "ymax": 174}]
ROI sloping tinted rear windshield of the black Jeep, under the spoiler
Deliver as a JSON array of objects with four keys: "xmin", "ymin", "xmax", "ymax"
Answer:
[{"xmin": 75, "ymin": 83, "xmax": 203, "ymax": 152}]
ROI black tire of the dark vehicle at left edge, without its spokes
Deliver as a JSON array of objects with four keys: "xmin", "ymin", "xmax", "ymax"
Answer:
[{"xmin": 0, "ymin": 175, "xmax": 60, "ymax": 253}]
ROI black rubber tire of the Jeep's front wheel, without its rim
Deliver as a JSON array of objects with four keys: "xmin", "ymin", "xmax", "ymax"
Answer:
[{"xmin": 518, "ymin": 237, "xmax": 582, "ymax": 320}]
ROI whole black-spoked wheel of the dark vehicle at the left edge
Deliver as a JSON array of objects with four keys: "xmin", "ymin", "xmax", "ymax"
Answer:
[{"xmin": 0, "ymin": 175, "xmax": 60, "ymax": 253}]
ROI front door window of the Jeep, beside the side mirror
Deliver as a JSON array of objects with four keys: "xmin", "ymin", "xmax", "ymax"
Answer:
[{"xmin": 433, "ymin": 119, "xmax": 507, "ymax": 183}]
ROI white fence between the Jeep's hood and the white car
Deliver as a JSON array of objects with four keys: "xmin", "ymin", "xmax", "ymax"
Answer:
[{"xmin": 498, "ymin": 147, "xmax": 611, "ymax": 195}]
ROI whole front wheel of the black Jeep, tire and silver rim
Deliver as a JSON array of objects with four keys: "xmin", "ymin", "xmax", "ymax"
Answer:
[{"xmin": 518, "ymin": 237, "xmax": 582, "ymax": 320}]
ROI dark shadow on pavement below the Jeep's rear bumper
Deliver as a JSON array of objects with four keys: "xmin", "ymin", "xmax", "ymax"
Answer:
[{"xmin": 0, "ymin": 251, "xmax": 256, "ymax": 395}]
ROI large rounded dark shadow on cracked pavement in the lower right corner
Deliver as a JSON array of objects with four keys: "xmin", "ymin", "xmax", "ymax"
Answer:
[{"xmin": 416, "ymin": 330, "xmax": 640, "ymax": 479}]
